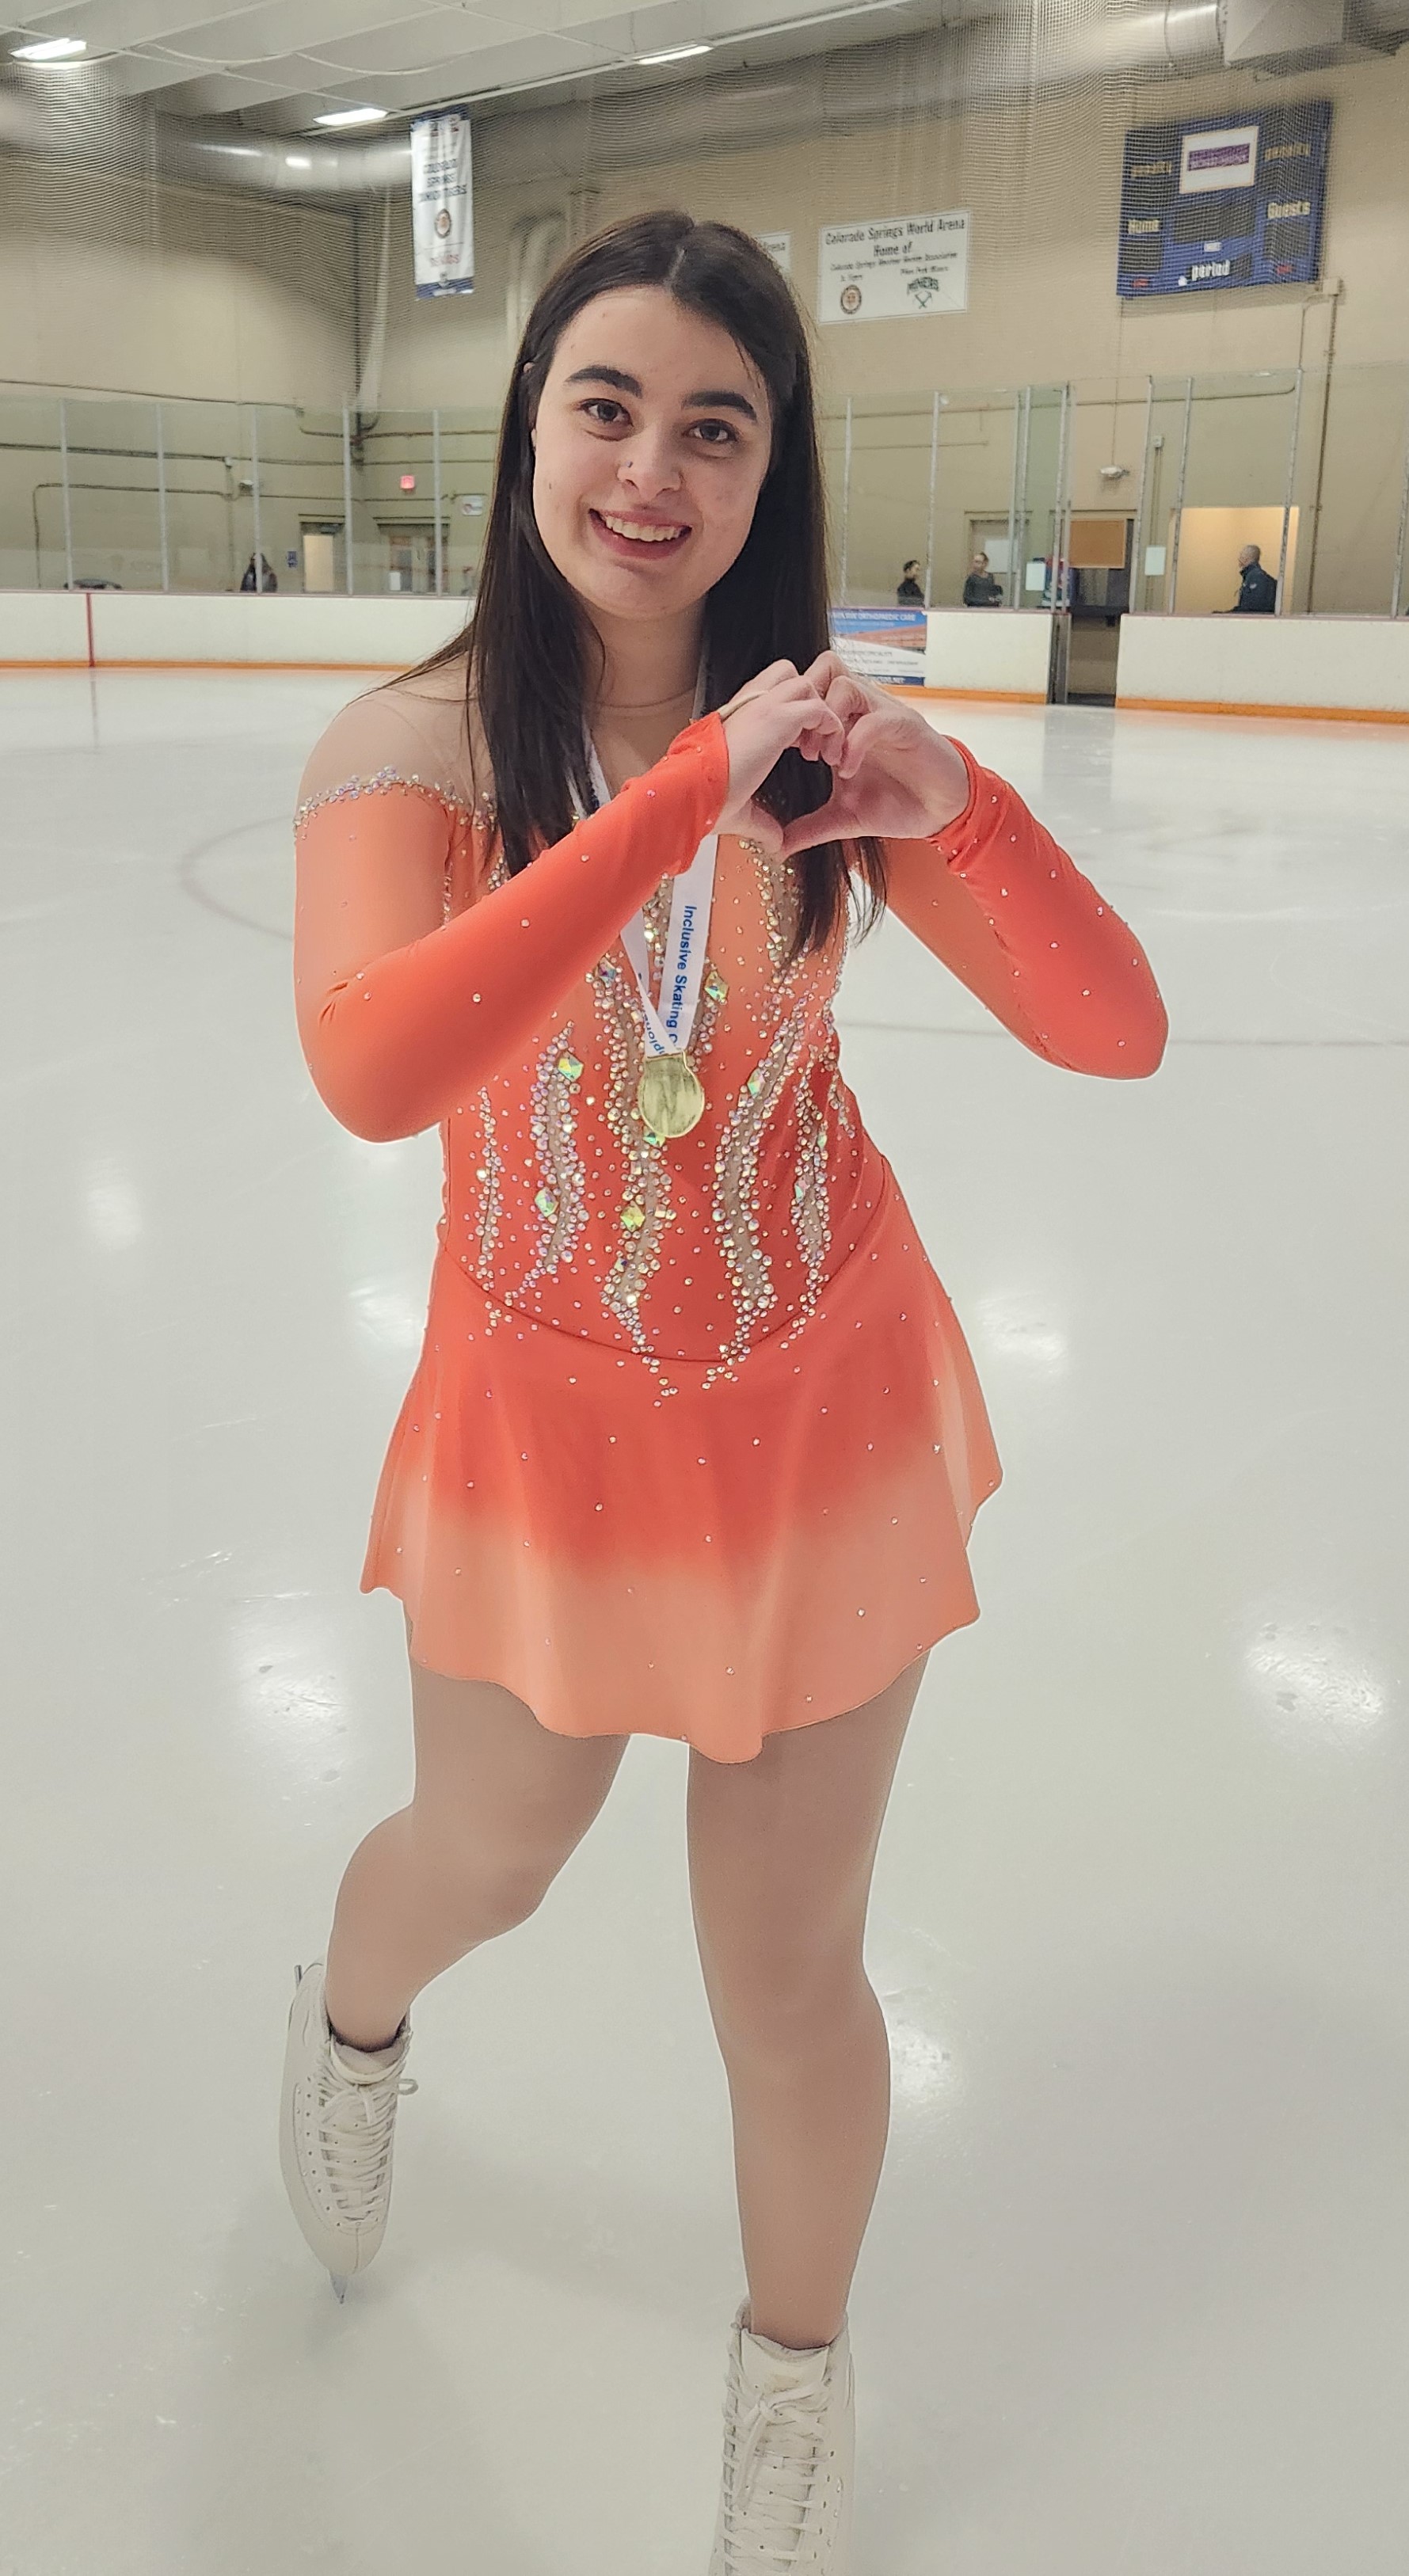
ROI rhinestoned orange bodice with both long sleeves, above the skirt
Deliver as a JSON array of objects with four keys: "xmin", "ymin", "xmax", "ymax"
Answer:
[{"xmin": 294, "ymin": 664, "xmax": 1167, "ymax": 1396}]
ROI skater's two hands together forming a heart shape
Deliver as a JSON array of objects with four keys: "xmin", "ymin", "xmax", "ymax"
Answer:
[{"xmin": 718, "ymin": 652, "xmax": 969, "ymax": 858}]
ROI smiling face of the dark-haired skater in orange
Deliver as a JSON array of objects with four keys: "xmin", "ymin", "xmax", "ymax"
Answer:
[{"xmin": 533, "ymin": 286, "xmax": 773, "ymax": 618}]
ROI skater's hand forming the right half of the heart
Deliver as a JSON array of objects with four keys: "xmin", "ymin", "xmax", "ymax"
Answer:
[{"xmin": 783, "ymin": 652, "xmax": 969, "ymax": 858}]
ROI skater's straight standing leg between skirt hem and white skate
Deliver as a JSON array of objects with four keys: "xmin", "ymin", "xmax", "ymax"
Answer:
[{"xmin": 687, "ymin": 1657, "xmax": 925, "ymax": 2350}]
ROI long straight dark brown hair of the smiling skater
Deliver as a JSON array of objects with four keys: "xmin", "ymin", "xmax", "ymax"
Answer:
[{"xmin": 420, "ymin": 208, "xmax": 886, "ymax": 956}]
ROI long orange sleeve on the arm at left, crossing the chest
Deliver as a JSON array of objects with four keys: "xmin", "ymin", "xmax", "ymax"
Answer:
[{"xmin": 294, "ymin": 701, "xmax": 729, "ymax": 1139}]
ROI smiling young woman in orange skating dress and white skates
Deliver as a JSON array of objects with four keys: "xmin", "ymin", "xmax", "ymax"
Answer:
[{"xmin": 280, "ymin": 214, "xmax": 1164, "ymax": 2576}]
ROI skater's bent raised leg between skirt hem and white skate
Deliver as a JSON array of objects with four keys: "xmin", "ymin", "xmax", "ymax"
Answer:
[{"xmin": 327, "ymin": 1627, "xmax": 626, "ymax": 2048}]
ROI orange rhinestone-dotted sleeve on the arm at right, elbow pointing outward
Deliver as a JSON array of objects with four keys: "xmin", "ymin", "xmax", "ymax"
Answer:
[{"xmin": 886, "ymin": 742, "xmax": 1170, "ymax": 1077}]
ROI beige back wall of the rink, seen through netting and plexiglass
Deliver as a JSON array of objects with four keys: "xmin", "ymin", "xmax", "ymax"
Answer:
[{"xmin": 0, "ymin": 0, "xmax": 1409, "ymax": 613}]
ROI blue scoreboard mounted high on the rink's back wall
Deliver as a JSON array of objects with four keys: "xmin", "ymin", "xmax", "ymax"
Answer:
[{"xmin": 1115, "ymin": 98, "xmax": 1331, "ymax": 299}]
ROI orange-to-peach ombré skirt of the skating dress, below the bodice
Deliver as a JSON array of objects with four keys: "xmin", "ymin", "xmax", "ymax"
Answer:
[{"xmin": 360, "ymin": 1170, "xmax": 1002, "ymax": 1762}]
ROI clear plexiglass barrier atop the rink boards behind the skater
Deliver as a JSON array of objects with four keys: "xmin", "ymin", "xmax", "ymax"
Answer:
[{"xmin": 0, "ymin": 363, "xmax": 1409, "ymax": 615}]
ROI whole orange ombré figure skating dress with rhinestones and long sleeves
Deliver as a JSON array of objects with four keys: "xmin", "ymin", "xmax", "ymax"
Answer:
[{"xmin": 296, "ymin": 664, "xmax": 1164, "ymax": 1762}]
